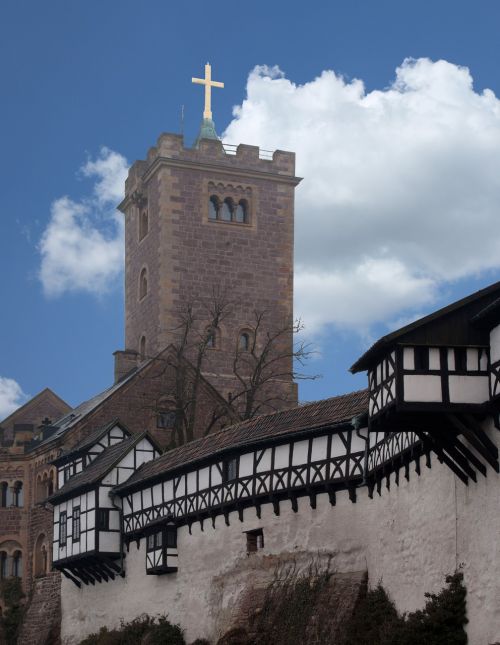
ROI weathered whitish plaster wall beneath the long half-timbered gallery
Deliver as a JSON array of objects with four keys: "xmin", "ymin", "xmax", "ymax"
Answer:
[{"xmin": 62, "ymin": 429, "xmax": 500, "ymax": 645}]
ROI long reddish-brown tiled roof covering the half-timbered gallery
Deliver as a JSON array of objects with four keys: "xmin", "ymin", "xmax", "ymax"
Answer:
[{"xmin": 117, "ymin": 390, "xmax": 368, "ymax": 490}]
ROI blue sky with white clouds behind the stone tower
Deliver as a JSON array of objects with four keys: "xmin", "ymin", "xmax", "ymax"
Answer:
[{"xmin": 0, "ymin": 0, "xmax": 500, "ymax": 416}]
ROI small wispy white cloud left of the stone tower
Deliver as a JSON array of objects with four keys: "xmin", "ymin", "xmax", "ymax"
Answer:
[{"xmin": 39, "ymin": 148, "xmax": 128, "ymax": 296}]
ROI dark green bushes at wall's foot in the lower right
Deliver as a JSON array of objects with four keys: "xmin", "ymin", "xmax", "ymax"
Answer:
[{"xmin": 345, "ymin": 572, "xmax": 468, "ymax": 645}]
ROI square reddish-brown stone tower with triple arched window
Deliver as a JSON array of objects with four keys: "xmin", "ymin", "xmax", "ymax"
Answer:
[{"xmin": 119, "ymin": 64, "xmax": 300, "ymax": 408}]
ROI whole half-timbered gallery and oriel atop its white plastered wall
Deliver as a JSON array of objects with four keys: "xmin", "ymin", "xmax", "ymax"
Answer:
[{"xmin": 54, "ymin": 283, "xmax": 500, "ymax": 645}]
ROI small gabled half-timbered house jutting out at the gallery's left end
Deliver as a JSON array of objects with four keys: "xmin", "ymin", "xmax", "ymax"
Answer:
[{"xmin": 49, "ymin": 422, "xmax": 160, "ymax": 586}]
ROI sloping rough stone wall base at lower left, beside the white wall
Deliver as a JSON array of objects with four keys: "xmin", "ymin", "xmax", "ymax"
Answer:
[{"xmin": 18, "ymin": 573, "xmax": 61, "ymax": 645}]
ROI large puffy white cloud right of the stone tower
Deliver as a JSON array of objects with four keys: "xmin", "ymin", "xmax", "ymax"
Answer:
[{"xmin": 224, "ymin": 59, "xmax": 500, "ymax": 330}]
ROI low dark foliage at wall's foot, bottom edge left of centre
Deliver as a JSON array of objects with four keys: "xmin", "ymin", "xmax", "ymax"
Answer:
[{"xmin": 80, "ymin": 614, "xmax": 186, "ymax": 645}]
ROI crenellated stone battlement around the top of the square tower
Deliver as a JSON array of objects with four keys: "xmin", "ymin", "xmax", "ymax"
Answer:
[{"xmin": 120, "ymin": 133, "xmax": 298, "ymax": 206}]
